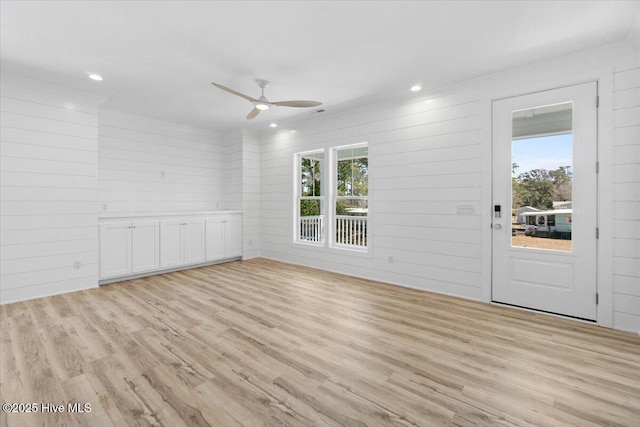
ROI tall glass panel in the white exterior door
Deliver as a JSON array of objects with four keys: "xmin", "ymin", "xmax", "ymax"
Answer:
[{"xmin": 511, "ymin": 102, "xmax": 573, "ymax": 251}]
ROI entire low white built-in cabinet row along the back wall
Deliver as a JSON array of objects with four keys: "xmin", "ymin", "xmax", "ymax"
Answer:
[{"xmin": 100, "ymin": 212, "xmax": 242, "ymax": 280}]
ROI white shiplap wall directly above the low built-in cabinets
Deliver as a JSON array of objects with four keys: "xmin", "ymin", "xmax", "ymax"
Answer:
[{"xmin": 99, "ymin": 110, "xmax": 226, "ymax": 213}]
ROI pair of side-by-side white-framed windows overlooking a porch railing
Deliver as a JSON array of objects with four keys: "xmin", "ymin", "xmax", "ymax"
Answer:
[{"xmin": 295, "ymin": 143, "xmax": 369, "ymax": 250}]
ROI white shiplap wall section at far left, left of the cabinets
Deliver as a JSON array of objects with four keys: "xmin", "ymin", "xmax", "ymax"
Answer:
[{"xmin": 0, "ymin": 73, "xmax": 102, "ymax": 303}]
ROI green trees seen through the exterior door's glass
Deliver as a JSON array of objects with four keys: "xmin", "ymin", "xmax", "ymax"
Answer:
[{"xmin": 512, "ymin": 163, "xmax": 573, "ymax": 209}]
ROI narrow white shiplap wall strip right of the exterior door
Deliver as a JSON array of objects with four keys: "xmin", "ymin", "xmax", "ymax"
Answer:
[{"xmin": 613, "ymin": 59, "xmax": 640, "ymax": 332}]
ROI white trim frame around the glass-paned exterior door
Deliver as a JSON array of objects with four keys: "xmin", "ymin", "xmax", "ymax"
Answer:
[{"xmin": 479, "ymin": 70, "xmax": 614, "ymax": 328}]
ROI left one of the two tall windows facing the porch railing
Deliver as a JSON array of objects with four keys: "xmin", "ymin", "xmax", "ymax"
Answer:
[{"xmin": 296, "ymin": 151, "xmax": 325, "ymax": 243}]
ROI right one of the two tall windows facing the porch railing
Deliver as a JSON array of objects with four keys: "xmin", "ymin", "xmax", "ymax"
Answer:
[{"xmin": 334, "ymin": 145, "xmax": 369, "ymax": 248}]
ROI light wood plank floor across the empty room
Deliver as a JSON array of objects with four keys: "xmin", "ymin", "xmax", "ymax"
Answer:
[{"xmin": 0, "ymin": 259, "xmax": 640, "ymax": 427}]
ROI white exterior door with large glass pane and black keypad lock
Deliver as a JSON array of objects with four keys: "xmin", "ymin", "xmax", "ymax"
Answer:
[{"xmin": 492, "ymin": 82, "xmax": 597, "ymax": 320}]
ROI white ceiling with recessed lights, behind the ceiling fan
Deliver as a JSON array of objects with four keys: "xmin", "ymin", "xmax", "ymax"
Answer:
[{"xmin": 0, "ymin": 0, "xmax": 640, "ymax": 130}]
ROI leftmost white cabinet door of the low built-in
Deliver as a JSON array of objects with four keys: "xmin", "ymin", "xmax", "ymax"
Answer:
[{"xmin": 100, "ymin": 222, "xmax": 131, "ymax": 279}]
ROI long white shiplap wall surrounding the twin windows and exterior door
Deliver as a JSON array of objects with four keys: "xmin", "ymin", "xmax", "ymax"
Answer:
[{"xmin": 261, "ymin": 43, "xmax": 640, "ymax": 331}]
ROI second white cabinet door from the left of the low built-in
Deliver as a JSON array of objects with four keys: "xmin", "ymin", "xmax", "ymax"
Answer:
[{"xmin": 131, "ymin": 221, "xmax": 160, "ymax": 273}]
